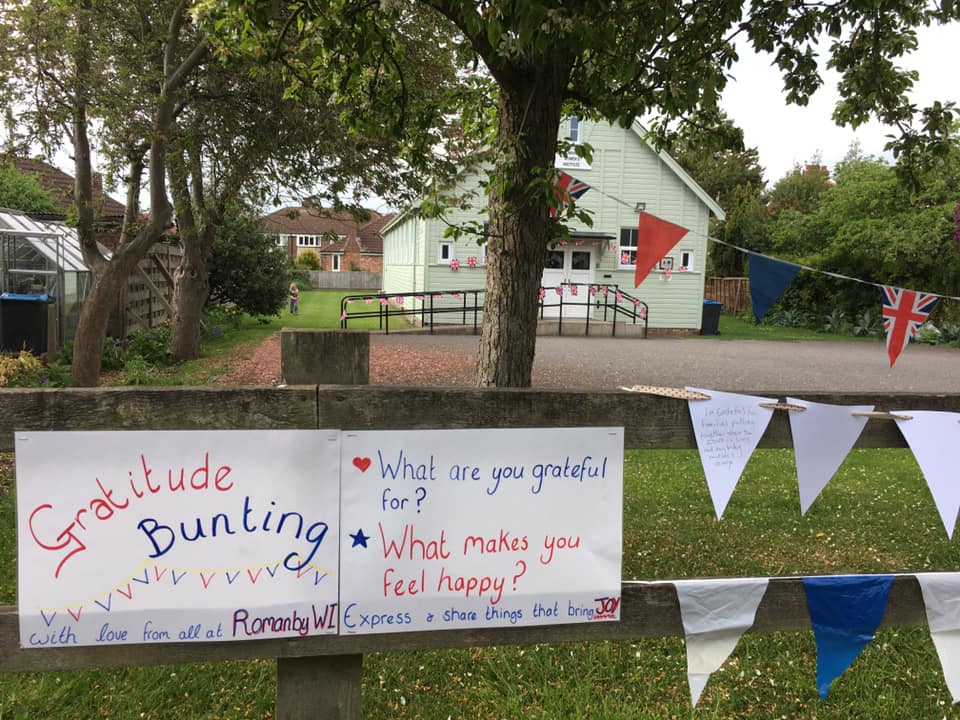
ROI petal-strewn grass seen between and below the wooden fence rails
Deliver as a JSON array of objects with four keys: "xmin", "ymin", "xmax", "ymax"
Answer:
[{"xmin": 0, "ymin": 450, "xmax": 960, "ymax": 720}]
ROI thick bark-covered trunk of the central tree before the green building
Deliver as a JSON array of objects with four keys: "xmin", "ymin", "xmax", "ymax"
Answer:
[{"xmin": 477, "ymin": 64, "xmax": 568, "ymax": 387}]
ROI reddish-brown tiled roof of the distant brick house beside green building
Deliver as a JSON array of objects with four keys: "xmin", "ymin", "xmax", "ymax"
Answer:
[{"xmin": 263, "ymin": 206, "xmax": 394, "ymax": 255}]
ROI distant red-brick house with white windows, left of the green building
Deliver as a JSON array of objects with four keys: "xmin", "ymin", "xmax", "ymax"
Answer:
[{"xmin": 263, "ymin": 206, "xmax": 394, "ymax": 272}]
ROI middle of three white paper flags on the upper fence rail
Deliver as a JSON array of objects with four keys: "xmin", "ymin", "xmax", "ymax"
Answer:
[{"xmin": 787, "ymin": 397, "xmax": 873, "ymax": 515}]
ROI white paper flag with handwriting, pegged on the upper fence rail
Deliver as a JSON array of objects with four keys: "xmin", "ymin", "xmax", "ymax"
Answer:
[{"xmin": 687, "ymin": 388, "xmax": 776, "ymax": 520}]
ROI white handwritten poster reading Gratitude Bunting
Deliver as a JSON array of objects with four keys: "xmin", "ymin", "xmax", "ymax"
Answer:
[{"xmin": 16, "ymin": 430, "xmax": 340, "ymax": 647}]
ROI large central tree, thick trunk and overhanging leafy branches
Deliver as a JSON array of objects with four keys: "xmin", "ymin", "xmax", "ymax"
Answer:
[{"xmin": 218, "ymin": 0, "xmax": 960, "ymax": 386}]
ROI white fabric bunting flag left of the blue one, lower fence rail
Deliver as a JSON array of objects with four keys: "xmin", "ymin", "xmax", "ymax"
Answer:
[{"xmin": 673, "ymin": 578, "xmax": 769, "ymax": 705}]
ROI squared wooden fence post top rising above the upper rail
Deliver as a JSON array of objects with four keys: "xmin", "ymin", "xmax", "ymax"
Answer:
[{"xmin": 280, "ymin": 328, "xmax": 370, "ymax": 385}]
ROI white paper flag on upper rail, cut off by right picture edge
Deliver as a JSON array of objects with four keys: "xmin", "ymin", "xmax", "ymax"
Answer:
[{"xmin": 893, "ymin": 410, "xmax": 960, "ymax": 538}]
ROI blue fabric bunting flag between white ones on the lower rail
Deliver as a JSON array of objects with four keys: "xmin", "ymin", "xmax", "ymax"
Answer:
[{"xmin": 803, "ymin": 575, "xmax": 893, "ymax": 699}]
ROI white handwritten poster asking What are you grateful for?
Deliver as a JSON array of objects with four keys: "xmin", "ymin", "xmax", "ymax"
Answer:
[{"xmin": 340, "ymin": 428, "xmax": 623, "ymax": 634}]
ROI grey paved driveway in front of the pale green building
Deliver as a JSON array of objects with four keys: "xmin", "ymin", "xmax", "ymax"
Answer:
[{"xmin": 371, "ymin": 333, "xmax": 960, "ymax": 393}]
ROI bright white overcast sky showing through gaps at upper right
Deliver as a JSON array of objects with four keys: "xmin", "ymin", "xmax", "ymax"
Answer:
[{"xmin": 723, "ymin": 23, "xmax": 960, "ymax": 185}]
